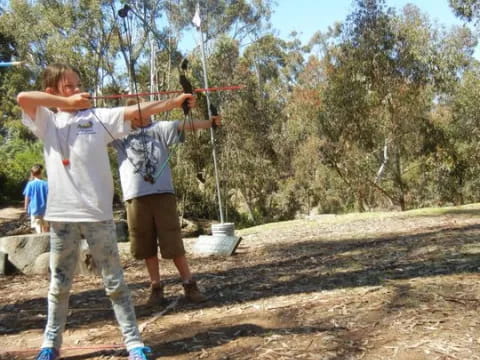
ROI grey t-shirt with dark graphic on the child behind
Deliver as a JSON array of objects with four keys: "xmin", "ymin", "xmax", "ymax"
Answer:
[{"xmin": 112, "ymin": 121, "xmax": 183, "ymax": 201}]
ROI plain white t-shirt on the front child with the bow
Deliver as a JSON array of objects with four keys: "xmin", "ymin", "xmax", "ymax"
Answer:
[{"xmin": 22, "ymin": 107, "xmax": 130, "ymax": 222}]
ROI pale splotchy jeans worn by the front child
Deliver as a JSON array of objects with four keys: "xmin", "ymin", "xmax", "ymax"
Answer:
[{"xmin": 42, "ymin": 220, "xmax": 144, "ymax": 350}]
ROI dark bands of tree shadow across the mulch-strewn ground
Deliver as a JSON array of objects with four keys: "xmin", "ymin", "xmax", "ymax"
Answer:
[{"xmin": 0, "ymin": 221, "xmax": 480, "ymax": 360}]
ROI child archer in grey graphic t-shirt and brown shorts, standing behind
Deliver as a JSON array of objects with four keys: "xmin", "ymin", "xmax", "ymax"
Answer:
[{"xmin": 113, "ymin": 100, "xmax": 221, "ymax": 305}]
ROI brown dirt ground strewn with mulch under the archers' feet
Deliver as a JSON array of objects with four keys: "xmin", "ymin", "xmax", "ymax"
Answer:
[{"xmin": 0, "ymin": 204, "xmax": 480, "ymax": 360}]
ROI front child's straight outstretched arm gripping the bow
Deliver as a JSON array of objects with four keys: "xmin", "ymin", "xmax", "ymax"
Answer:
[{"xmin": 124, "ymin": 94, "xmax": 195, "ymax": 121}]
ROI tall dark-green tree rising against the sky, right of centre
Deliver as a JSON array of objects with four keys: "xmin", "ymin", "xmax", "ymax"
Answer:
[{"xmin": 319, "ymin": 0, "xmax": 403, "ymax": 210}]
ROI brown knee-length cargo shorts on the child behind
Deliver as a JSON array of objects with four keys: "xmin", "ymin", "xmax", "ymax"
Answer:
[{"xmin": 125, "ymin": 193, "xmax": 185, "ymax": 259}]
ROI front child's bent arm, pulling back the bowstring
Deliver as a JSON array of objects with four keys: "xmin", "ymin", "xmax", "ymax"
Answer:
[{"xmin": 17, "ymin": 91, "xmax": 92, "ymax": 119}]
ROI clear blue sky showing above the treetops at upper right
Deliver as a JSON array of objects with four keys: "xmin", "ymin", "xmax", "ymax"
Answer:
[{"xmin": 271, "ymin": 0, "xmax": 462, "ymax": 43}]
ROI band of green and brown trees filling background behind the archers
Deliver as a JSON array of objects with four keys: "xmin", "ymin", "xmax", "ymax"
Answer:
[{"xmin": 0, "ymin": 0, "xmax": 480, "ymax": 221}]
